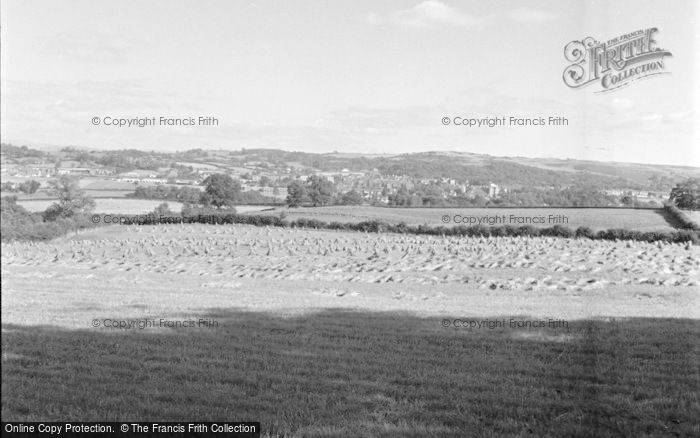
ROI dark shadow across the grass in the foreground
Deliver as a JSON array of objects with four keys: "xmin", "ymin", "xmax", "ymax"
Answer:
[{"xmin": 2, "ymin": 310, "xmax": 700, "ymax": 436}]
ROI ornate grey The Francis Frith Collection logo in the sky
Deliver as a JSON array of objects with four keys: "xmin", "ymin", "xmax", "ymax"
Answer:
[{"xmin": 564, "ymin": 27, "xmax": 673, "ymax": 93}]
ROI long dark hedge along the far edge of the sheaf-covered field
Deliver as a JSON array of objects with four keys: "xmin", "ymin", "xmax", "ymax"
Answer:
[{"xmin": 124, "ymin": 213, "xmax": 700, "ymax": 243}]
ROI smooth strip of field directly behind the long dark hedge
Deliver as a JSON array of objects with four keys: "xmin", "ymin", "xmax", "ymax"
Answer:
[{"xmin": 254, "ymin": 206, "xmax": 674, "ymax": 231}]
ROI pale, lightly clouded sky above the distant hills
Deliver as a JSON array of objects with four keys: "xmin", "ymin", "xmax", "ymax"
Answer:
[{"xmin": 0, "ymin": 0, "xmax": 700, "ymax": 166}]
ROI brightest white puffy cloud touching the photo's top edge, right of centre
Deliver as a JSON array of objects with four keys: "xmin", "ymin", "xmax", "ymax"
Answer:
[{"xmin": 367, "ymin": 0, "xmax": 485, "ymax": 28}]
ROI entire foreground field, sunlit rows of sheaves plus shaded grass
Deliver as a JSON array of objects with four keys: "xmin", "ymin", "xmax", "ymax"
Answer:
[{"xmin": 2, "ymin": 225, "xmax": 700, "ymax": 436}]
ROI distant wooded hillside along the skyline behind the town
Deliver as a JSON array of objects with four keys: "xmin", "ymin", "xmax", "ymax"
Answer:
[{"xmin": 5, "ymin": 143, "xmax": 700, "ymax": 192}]
